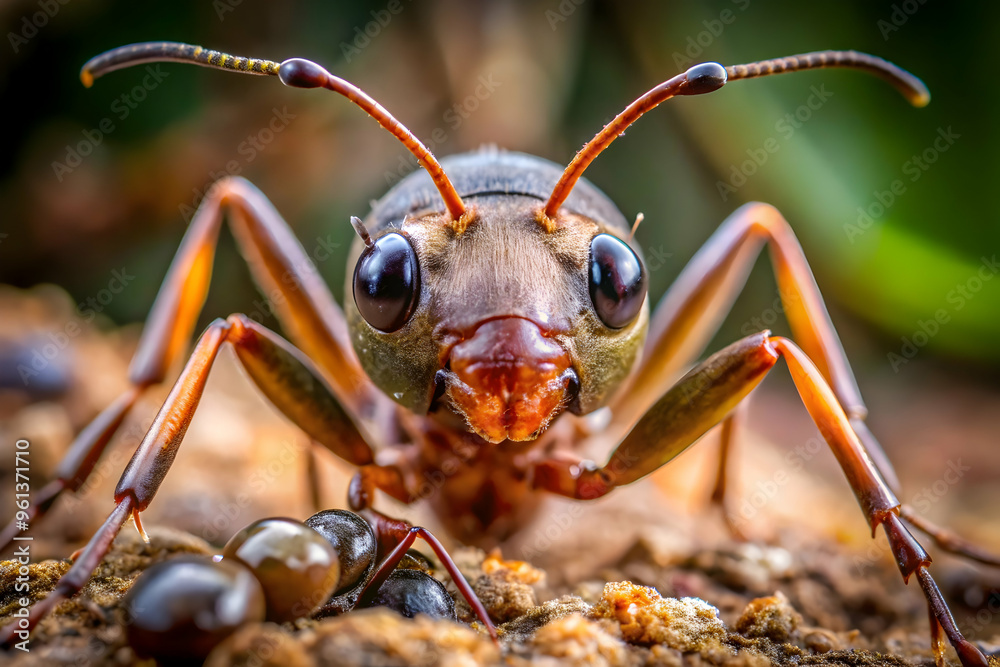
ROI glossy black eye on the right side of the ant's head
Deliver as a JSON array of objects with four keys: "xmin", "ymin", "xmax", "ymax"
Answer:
[{"xmin": 590, "ymin": 234, "xmax": 646, "ymax": 329}]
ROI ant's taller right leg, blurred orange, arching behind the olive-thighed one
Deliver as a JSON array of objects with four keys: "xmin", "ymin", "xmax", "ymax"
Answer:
[{"xmin": 611, "ymin": 203, "xmax": 899, "ymax": 492}]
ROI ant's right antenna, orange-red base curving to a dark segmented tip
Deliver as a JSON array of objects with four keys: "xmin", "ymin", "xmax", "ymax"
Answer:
[{"xmin": 542, "ymin": 51, "xmax": 931, "ymax": 219}]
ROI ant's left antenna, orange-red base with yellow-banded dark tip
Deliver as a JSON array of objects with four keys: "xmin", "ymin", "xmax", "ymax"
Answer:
[{"xmin": 80, "ymin": 42, "xmax": 466, "ymax": 221}]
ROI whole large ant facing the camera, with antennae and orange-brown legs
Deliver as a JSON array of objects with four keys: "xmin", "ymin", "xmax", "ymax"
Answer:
[{"xmin": 0, "ymin": 42, "xmax": 1000, "ymax": 667}]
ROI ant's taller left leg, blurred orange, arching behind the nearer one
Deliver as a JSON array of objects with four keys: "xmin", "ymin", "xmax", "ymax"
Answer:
[{"xmin": 0, "ymin": 178, "xmax": 377, "ymax": 552}]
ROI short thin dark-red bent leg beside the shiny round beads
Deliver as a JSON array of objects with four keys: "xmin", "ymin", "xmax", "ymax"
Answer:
[{"xmin": 348, "ymin": 465, "xmax": 499, "ymax": 643}]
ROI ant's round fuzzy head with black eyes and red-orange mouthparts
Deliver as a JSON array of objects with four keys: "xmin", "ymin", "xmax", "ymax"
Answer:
[{"xmin": 345, "ymin": 152, "xmax": 648, "ymax": 443}]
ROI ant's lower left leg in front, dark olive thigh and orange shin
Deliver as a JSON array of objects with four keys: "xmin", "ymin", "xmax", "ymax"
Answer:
[{"xmin": 0, "ymin": 315, "xmax": 373, "ymax": 645}]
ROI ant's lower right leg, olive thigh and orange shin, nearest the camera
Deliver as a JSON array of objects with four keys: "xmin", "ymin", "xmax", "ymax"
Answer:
[{"xmin": 534, "ymin": 332, "xmax": 987, "ymax": 667}]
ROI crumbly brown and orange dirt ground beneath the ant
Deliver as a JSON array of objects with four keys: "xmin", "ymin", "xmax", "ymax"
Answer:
[{"xmin": 0, "ymin": 288, "xmax": 1000, "ymax": 667}]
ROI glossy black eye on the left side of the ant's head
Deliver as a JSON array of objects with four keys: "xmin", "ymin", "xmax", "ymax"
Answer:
[{"xmin": 354, "ymin": 232, "xmax": 420, "ymax": 333}]
